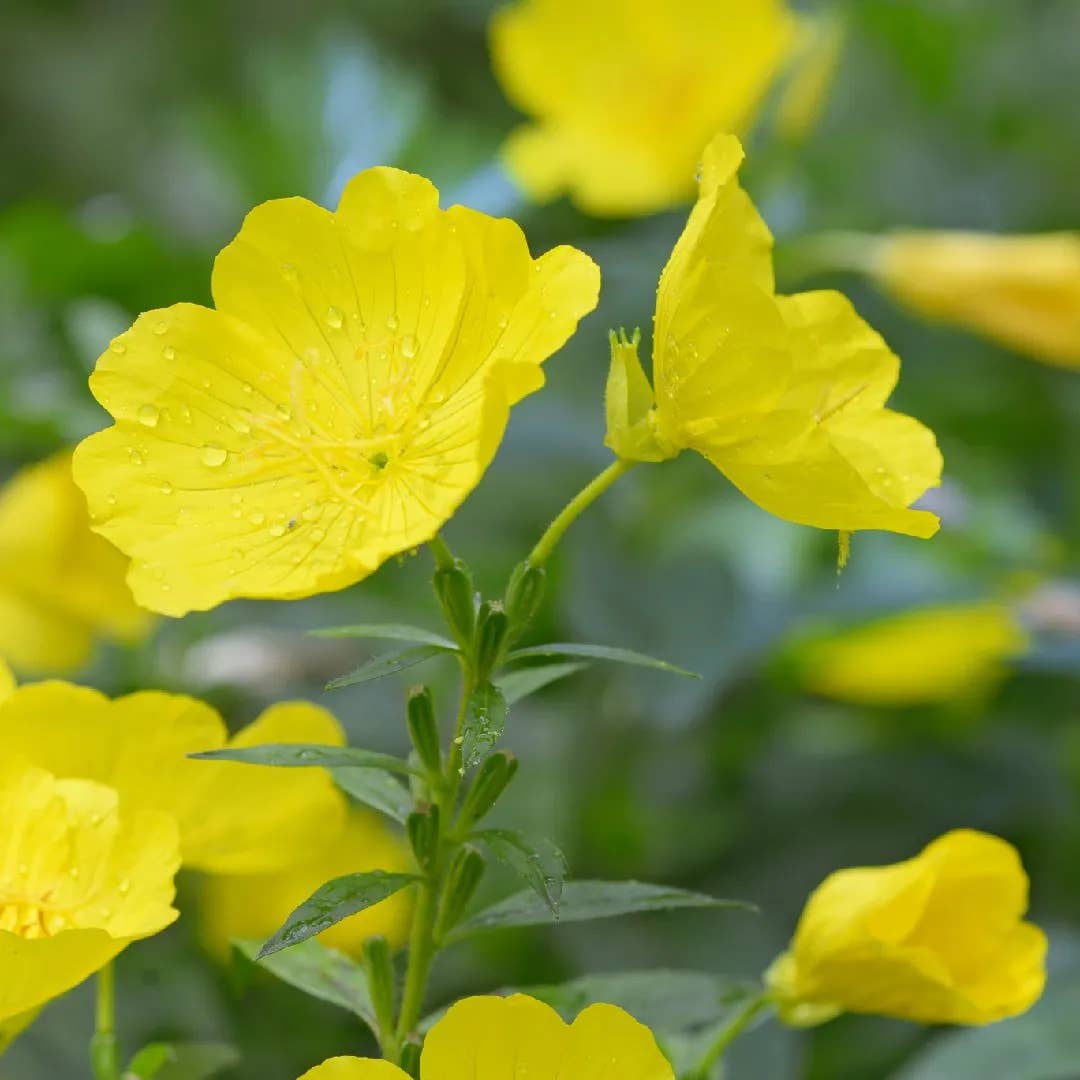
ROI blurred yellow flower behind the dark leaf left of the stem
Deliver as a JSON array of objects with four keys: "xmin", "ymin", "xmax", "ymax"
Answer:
[{"xmin": 201, "ymin": 810, "xmax": 413, "ymax": 959}]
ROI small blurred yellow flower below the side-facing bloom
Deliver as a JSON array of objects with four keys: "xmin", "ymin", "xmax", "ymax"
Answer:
[{"xmin": 793, "ymin": 604, "xmax": 1027, "ymax": 705}]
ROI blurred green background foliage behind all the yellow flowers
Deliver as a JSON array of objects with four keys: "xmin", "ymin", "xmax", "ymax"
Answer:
[{"xmin": 0, "ymin": 0, "xmax": 1080, "ymax": 1080}]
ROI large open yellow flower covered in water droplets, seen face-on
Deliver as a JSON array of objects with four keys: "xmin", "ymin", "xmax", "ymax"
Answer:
[{"xmin": 75, "ymin": 168, "xmax": 599, "ymax": 616}]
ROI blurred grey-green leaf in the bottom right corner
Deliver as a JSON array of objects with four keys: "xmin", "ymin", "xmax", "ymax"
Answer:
[{"xmin": 896, "ymin": 968, "xmax": 1080, "ymax": 1080}]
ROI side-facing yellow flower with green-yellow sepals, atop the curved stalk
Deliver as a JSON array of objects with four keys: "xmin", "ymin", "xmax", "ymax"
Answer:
[{"xmin": 607, "ymin": 135, "xmax": 942, "ymax": 537}]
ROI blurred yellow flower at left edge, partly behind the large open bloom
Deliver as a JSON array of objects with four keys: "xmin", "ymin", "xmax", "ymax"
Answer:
[{"xmin": 0, "ymin": 451, "xmax": 150, "ymax": 672}]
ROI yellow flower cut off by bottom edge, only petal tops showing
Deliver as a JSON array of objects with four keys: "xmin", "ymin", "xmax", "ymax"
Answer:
[{"xmin": 301, "ymin": 994, "xmax": 675, "ymax": 1080}]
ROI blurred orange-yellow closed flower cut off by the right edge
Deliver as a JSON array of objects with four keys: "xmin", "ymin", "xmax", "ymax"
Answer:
[{"xmin": 868, "ymin": 231, "xmax": 1080, "ymax": 367}]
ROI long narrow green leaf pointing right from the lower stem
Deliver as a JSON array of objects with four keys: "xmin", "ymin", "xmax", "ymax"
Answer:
[{"xmin": 455, "ymin": 881, "xmax": 755, "ymax": 936}]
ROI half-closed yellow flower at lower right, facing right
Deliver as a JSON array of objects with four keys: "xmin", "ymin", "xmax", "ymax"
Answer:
[{"xmin": 768, "ymin": 829, "xmax": 1047, "ymax": 1025}]
